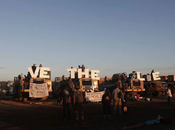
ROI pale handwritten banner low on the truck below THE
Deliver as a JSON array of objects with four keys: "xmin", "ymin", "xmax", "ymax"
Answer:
[{"xmin": 85, "ymin": 91, "xmax": 105, "ymax": 102}]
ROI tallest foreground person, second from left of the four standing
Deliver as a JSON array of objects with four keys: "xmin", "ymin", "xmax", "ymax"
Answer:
[{"xmin": 73, "ymin": 84, "xmax": 84, "ymax": 124}]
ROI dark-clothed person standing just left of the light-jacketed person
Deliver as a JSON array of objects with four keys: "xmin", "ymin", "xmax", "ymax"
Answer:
[{"xmin": 102, "ymin": 89, "xmax": 111, "ymax": 118}]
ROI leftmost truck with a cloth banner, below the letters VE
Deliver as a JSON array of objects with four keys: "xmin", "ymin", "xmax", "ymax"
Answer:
[{"xmin": 13, "ymin": 66, "xmax": 52, "ymax": 101}]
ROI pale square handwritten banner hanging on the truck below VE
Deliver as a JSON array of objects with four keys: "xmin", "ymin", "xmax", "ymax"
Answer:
[{"xmin": 29, "ymin": 83, "xmax": 49, "ymax": 98}]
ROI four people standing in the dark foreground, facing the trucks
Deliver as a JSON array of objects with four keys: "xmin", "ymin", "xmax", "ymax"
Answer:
[{"xmin": 58, "ymin": 84, "xmax": 127, "ymax": 124}]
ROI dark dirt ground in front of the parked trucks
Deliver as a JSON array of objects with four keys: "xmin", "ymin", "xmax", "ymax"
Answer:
[{"xmin": 0, "ymin": 96, "xmax": 175, "ymax": 130}]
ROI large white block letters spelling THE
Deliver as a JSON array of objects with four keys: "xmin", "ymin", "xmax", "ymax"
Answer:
[{"xmin": 67, "ymin": 68, "xmax": 100, "ymax": 80}]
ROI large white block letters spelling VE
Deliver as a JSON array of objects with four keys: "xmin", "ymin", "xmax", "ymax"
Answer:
[{"xmin": 28, "ymin": 67, "xmax": 50, "ymax": 79}]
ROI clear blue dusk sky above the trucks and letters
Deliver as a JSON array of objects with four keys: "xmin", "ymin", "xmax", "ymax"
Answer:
[{"xmin": 0, "ymin": 0, "xmax": 175, "ymax": 81}]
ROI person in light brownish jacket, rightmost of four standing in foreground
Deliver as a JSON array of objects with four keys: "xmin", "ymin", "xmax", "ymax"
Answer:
[{"xmin": 112, "ymin": 83, "xmax": 122, "ymax": 115}]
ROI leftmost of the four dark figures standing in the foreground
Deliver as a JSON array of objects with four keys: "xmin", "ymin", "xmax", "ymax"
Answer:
[{"xmin": 62, "ymin": 86, "xmax": 71, "ymax": 119}]
